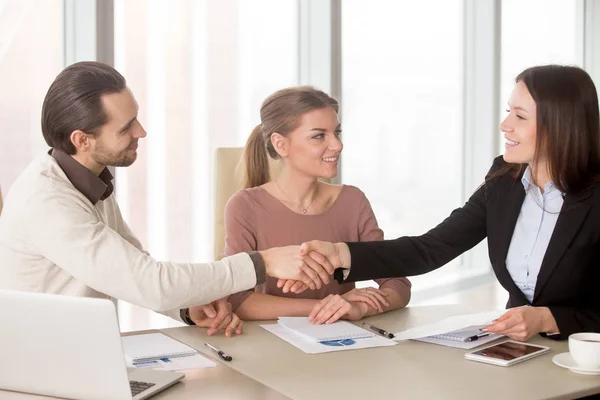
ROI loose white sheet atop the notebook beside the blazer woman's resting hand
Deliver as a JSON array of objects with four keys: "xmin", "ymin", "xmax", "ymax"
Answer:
[{"xmin": 394, "ymin": 310, "xmax": 506, "ymax": 340}]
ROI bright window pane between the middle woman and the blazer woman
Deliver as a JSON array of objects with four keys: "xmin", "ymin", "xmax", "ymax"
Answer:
[{"xmin": 342, "ymin": 0, "xmax": 463, "ymax": 287}]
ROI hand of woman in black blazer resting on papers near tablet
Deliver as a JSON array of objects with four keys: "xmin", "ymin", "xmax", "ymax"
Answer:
[{"xmin": 482, "ymin": 306, "xmax": 558, "ymax": 342}]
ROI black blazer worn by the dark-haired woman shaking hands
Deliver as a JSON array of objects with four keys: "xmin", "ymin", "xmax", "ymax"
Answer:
[{"xmin": 342, "ymin": 157, "xmax": 600, "ymax": 339}]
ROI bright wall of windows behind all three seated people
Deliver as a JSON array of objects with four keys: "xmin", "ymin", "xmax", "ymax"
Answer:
[{"xmin": 0, "ymin": 0, "xmax": 600, "ymax": 330}]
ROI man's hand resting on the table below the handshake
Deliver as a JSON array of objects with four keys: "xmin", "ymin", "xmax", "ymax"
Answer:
[{"xmin": 190, "ymin": 298, "xmax": 244, "ymax": 337}]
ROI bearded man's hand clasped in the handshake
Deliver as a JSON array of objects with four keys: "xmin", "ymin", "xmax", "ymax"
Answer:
[{"xmin": 260, "ymin": 246, "xmax": 333, "ymax": 290}]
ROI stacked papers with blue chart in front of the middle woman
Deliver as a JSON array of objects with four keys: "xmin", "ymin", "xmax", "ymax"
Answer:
[{"xmin": 261, "ymin": 317, "xmax": 396, "ymax": 354}]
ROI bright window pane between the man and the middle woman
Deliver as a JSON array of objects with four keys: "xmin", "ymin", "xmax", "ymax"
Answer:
[{"xmin": 114, "ymin": 0, "xmax": 298, "ymax": 330}]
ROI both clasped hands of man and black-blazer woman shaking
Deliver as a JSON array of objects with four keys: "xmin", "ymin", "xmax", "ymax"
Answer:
[{"xmin": 260, "ymin": 240, "xmax": 350, "ymax": 293}]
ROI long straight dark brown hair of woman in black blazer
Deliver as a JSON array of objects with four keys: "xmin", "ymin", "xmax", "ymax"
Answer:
[{"xmin": 492, "ymin": 65, "xmax": 600, "ymax": 193}]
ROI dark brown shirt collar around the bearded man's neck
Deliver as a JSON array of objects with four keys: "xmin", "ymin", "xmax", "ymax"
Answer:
[{"xmin": 49, "ymin": 149, "xmax": 114, "ymax": 205}]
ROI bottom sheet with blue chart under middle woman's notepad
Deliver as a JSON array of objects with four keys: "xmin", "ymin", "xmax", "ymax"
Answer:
[{"xmin": 261, "ymin": 324, "xmax": 397, "ymax": 354}]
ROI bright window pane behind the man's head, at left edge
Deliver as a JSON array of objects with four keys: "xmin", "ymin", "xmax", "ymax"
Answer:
[{"xmin": 0, "ymin": 0, "xmax": 64, "ymax": 195}]
